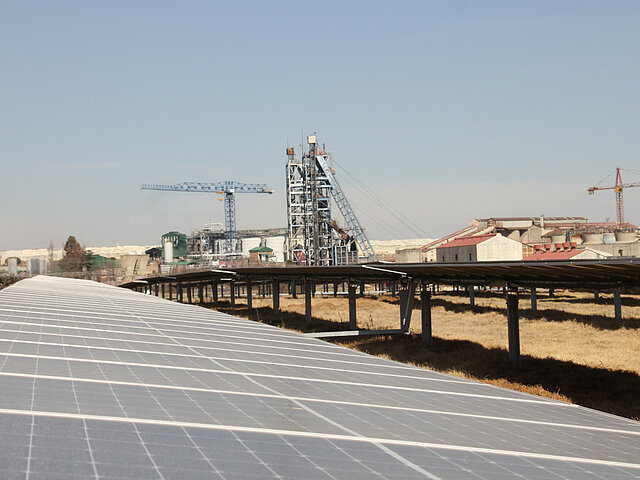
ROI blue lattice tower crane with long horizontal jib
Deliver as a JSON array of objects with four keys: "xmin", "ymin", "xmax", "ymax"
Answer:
[{"xmin": 142, "ymin": 180, "xmax": 274, "ymax": 256}]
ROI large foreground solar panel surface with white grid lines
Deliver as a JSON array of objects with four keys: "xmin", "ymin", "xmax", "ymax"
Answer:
[{"xmin": 0, "ymin": 277, "xmax": 640, "ymax": 480}]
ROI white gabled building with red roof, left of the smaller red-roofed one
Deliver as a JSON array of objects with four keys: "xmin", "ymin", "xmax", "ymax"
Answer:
[{"xmin": 436, "ymin": 233, "xmax": 522, "ymax": 263}]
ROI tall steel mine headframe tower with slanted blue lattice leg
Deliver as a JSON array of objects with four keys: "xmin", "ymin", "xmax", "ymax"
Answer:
[{"xmin": 286, "ymin": 135, "xmax": 378, "ymax": 266}]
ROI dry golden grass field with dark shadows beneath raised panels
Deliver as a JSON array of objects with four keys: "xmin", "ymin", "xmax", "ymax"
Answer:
[{"xmin": 210, "ymin": 291, "xmax": 640, "ymax": 420}]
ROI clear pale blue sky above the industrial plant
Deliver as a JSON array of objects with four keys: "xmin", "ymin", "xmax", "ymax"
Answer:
[{"xmin": 0, "ymin": 0, "xmax": 640, "ymax": 250}]
